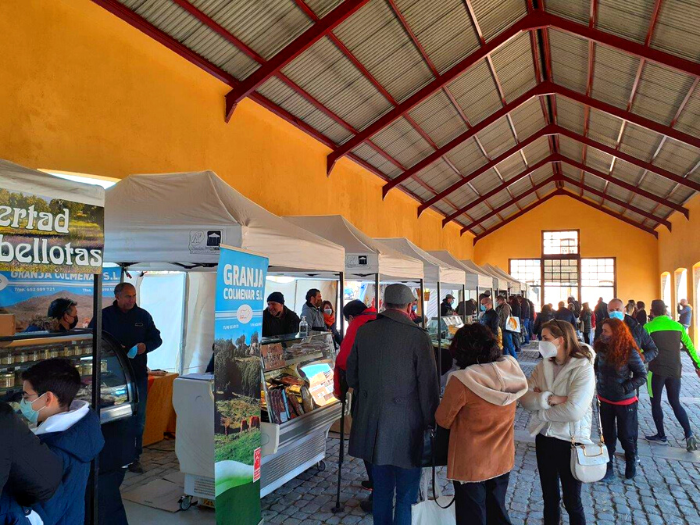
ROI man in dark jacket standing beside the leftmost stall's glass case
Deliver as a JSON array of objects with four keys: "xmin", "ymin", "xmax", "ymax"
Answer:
[{"xmin": 90, "ymin": 283, "xmax": 163, "ymax": 474}]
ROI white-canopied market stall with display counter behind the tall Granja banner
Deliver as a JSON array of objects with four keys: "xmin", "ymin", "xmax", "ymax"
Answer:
[{"xmin": 105, "ymin": 171, "xmax": 345, "ymax": 506}]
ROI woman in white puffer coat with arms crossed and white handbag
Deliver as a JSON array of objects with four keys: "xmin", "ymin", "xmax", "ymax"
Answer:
[{"xmin": 520, "ymin": 320, "xmax": 596, "ymax": 525}]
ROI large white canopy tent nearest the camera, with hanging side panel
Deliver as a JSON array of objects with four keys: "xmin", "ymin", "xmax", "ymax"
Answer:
[{"xmin": 105, "ymin": 171, "xmax": 345, "ymax": 372}]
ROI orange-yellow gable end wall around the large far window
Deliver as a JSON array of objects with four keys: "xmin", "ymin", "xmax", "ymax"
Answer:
[{"xmin": 474, "ymin": 196, "xmax": 660, "ymax": 305}]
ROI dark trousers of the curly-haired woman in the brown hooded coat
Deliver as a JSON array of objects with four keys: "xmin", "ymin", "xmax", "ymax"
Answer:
[{"xmin": 453, "ymin": 472, "xmax": 511, "ymax": 525}]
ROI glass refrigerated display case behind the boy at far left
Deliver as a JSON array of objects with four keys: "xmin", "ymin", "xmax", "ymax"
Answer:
[{"xmin": 0, "ymin": 330, "xmax": 137, "ymax": 424}]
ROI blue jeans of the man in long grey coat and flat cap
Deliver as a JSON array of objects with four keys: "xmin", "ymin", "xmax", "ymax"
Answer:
[{"xmin": 372, "ymin": 465, "xmax": 421, "ymax": 525}]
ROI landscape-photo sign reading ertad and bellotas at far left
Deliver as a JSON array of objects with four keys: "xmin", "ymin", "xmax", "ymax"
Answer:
[{"xmin": 0, "ymin": 189, "xmax": 104, "ymax": 273}]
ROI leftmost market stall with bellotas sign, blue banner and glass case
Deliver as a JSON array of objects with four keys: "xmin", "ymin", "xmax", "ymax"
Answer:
[{"xmin": 0, "ymin": 160, "xmax": 137, "ymax": 523}]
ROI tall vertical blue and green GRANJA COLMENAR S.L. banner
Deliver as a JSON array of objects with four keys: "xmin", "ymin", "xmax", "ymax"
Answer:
[{"xmin": 214, "ymin": 246, "xmax": 268, "ymax": 525}]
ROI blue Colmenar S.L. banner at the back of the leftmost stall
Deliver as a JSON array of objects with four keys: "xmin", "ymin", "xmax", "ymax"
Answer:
[{"xmin": 0, "ymin": 268, "xmax": 121, "ymax": 333}]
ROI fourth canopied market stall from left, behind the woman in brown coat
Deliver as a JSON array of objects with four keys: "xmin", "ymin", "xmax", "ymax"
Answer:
[{"xmin": 377, "ymin": 237, "xmax": 466, "ymax": 380}]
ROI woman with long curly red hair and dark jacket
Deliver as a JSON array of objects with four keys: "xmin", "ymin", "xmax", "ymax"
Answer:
[{"xmin": 595, "ymin": 319, "xmax": 646, "ymax": 481}]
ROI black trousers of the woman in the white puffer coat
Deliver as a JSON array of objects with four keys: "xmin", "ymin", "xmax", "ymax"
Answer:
[{"xmin": 535, "ymin": 434, "xmax": 586, "ymax": 525}]
